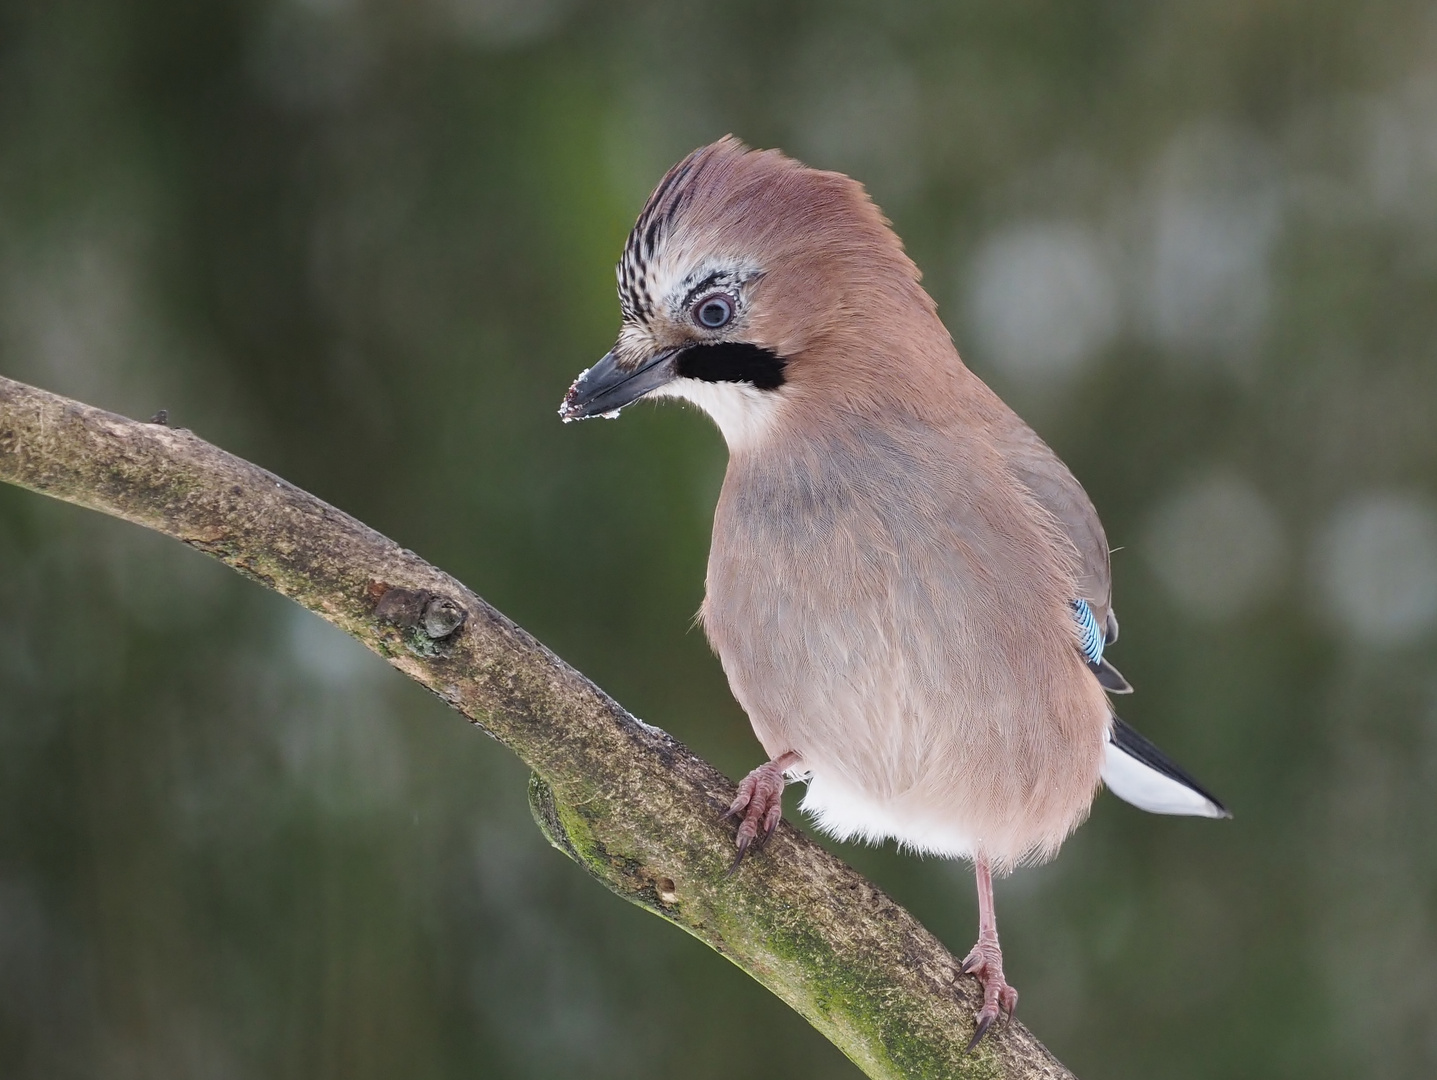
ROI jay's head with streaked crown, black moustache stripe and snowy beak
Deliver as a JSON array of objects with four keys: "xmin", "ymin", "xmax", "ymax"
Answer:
[{"xmin": 559, "ymin": 136, "xmax": 951, "ymax": 451}]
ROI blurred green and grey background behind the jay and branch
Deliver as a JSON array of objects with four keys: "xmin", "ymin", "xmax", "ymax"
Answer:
[{"xmin": 0, "ymin": 0, "xmax": 1437, "ymax": 1080}]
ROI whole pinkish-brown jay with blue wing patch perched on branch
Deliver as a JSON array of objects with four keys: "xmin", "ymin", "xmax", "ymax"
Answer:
[{"xmin": 559, "ymin": 135, "xmax": 1230, "ymax": 1050}]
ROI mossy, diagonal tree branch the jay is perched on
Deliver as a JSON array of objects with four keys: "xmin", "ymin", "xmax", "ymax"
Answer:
[{"xmin": 0, "ymin": 378, "xmax": 1071, "ymax": 1080}]
